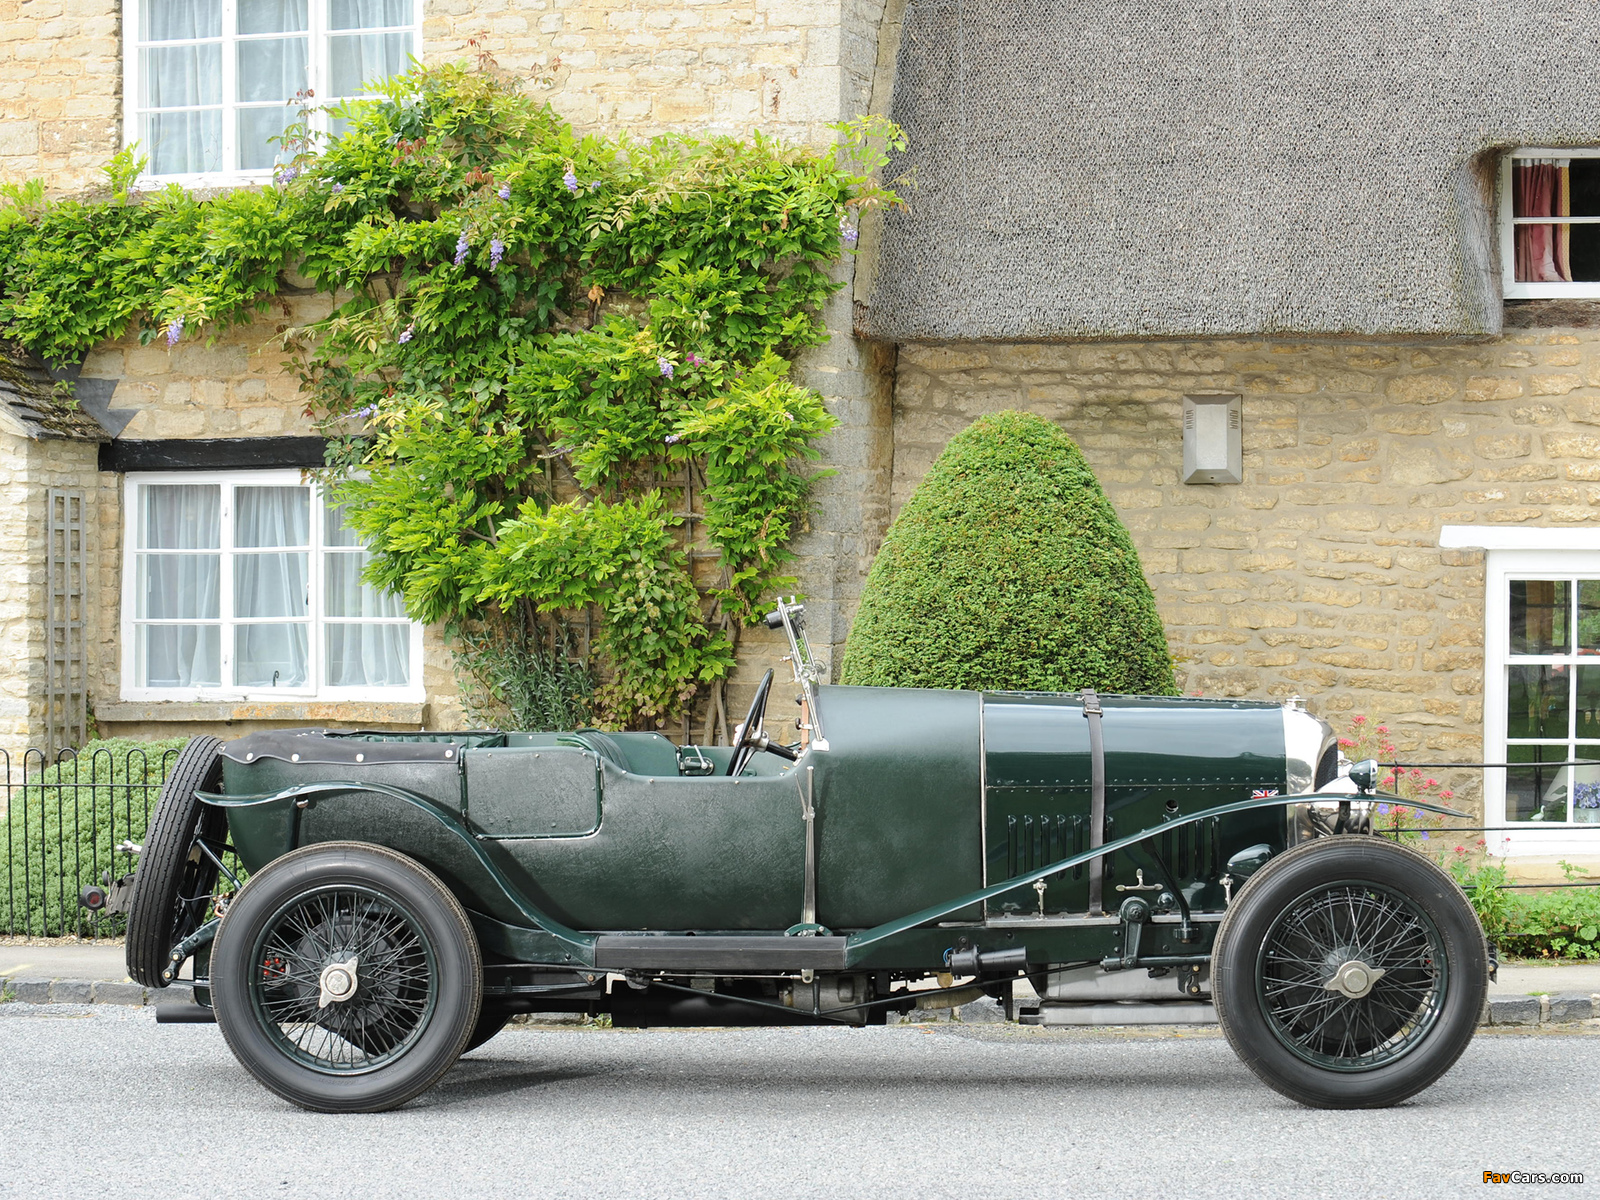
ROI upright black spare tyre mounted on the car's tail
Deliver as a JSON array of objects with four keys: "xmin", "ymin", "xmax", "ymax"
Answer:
[{"xmin": 126, "ymin": 734, "xmax": 227, "ymax": 987}]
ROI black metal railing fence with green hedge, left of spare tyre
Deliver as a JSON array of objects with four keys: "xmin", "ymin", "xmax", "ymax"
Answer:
[{"xmin": 0, "ymin": 746, "xmax": 178, "ymax": 938}]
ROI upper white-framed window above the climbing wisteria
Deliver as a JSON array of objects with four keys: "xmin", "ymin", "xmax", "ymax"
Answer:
[{"xmin": 123, "ymin": 0, "xmax": 421, "ymax": 184}]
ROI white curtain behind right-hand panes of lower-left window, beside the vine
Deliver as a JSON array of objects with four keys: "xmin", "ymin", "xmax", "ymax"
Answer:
[{"xmin": 323, "ymin": 506, "xmax": 411, "ymax": 688}]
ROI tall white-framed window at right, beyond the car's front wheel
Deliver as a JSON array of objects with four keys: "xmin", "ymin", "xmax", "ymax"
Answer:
[{"xmin": 1483, "ymin": 550, "xmax": 1600, "ymax": 854}]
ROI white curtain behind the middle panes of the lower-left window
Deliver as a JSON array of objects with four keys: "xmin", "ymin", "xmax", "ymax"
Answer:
[{"xmin": 234, "ymin": 486, "xmax": 310, "ymax": 688}]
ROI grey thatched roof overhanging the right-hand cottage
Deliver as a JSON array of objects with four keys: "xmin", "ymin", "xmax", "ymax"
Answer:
[{"xmin": 858, "ymin": 0, "xmax": 1600, "ymax": 341}]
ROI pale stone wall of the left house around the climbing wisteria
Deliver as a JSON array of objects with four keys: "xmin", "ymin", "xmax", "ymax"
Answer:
[{"xmin": 0, "ymin": 0, "xmax": 902, "ymax": 736}]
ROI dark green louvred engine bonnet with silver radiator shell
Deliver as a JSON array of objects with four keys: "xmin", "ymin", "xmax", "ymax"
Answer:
[{"xmin": 982, "ymin": 693, "xmax": 1338, "ymax": 915}]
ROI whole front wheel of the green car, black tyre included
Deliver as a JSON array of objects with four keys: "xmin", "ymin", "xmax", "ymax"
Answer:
[{"xmin": 1211, "ymin": 835, "xmax": 1488, "ymax": 1109}]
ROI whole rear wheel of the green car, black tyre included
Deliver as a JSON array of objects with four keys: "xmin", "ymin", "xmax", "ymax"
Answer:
[{"xmin": 211, "ymin": 842, "xmax": 483, "ymax": 1112}]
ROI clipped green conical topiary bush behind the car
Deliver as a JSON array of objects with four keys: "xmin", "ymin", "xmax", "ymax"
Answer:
[{"xmin": 840, "ymin": 413, "xmax": 1176, "ymax": 696}]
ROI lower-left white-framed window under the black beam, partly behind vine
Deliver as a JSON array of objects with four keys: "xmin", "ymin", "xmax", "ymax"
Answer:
[{"xmin": 122, "ymin": 470, "xmax": 422, "ymax": 701}]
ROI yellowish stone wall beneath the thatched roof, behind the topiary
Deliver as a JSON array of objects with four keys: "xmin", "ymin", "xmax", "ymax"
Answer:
[{"xmin": 893, "ymin": 310, "xmax": 1600, "ymax": 780}]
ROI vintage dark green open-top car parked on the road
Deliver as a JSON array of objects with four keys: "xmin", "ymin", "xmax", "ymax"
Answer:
[{"xmin": 128, "ymin": 603, "xmax": 1490, "ymax": 1112}]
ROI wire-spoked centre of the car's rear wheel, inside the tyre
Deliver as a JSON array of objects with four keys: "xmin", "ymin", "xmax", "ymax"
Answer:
[{"xmin": 250, "ymin": 888, "xmax": 438, "ymax": 1074}]
